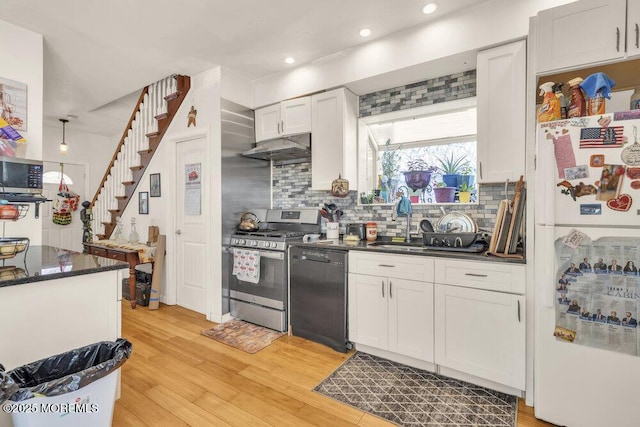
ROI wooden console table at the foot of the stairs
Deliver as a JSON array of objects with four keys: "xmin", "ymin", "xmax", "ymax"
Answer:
[{"xmin": 83, "ymin": 240, "xmax": 155, "ymax": 308}]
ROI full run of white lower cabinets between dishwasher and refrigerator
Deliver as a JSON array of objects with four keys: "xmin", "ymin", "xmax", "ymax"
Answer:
[{"xmin": 348, "ymin": 250, "xmax": 526, "ymax": 394}]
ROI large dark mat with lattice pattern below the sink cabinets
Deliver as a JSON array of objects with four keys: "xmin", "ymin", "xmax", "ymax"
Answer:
[{"xmin": 314, "ymin": 352, "xmax": 517, "ymax": 427}]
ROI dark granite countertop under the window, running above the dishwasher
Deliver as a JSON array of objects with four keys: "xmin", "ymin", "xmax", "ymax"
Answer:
[{"xmin": 292, "ymin": 236, "xmax": 526, "ymax": 264}]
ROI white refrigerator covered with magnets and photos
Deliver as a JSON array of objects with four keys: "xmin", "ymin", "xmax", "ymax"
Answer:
[{"xmin": 534, "ymin": 112, "xmax": 640, "ymax": 427}]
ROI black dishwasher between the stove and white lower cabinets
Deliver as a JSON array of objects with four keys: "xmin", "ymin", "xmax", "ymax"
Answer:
[{"xmin": 289, "ymin": 246, "xmax": 351, "ymax": 353}]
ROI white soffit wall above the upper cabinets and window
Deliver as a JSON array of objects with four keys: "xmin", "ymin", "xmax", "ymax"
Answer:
[{"xmin": 253, "ymin": 0, "xmax": 571, "ymax": 108}]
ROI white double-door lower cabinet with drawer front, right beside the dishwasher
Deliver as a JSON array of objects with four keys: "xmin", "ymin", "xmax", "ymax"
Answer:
[{"xmin": 349, "ymin": 251, "xmax": 433, "ymax": 362}]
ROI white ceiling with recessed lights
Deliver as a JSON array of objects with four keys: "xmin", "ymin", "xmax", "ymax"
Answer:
[{"xmin": 0, "ymin": 0, "xmax": 485, "ymax": 136}]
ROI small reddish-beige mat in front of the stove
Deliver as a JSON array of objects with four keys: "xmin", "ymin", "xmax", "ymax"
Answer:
[{"xmin": 200, "ymin": 320, "xmax": 284, "ymax": 354}]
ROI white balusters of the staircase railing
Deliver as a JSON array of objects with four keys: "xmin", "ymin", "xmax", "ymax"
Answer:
[{"xmin": 92, "ymin": 75, "xmax": 177, "ymax": 240}]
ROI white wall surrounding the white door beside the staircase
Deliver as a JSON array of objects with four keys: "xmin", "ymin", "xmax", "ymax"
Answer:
[{"xmin": 116, "ymin": 67, "xmax": 244, "ymax": 322}]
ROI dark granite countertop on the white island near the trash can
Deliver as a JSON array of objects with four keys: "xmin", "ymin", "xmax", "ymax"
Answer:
[{"xmin": 0, "ymin": 246, "xmax": 129, "ymax": 287}]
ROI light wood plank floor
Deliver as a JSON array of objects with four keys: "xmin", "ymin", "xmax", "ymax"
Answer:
[{"xmin": 113, "ymin": 300, "xmax": 551, "ymax": 427}]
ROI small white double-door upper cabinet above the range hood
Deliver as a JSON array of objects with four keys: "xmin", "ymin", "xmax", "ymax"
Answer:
[{"xmin": 255, "ymin": 96, "xmax": 311, "ymax": 142}]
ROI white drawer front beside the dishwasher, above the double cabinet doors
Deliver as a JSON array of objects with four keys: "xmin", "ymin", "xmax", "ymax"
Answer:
[{"xmin": 349, "ymin": 251, "xmax": 433, "ymax": 282}]
